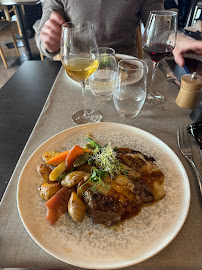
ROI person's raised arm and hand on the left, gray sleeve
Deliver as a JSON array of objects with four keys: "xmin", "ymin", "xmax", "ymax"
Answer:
[{"xmin": 36, "ymin": 0, "xmax": 67, "ymax": 58}]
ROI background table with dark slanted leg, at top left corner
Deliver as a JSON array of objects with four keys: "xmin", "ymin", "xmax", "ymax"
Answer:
[{"xmin": 0, "ymin": 0, "xmax": 41, "ymax": 60}]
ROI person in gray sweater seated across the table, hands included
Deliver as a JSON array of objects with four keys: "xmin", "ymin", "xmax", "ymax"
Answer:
[{"xmin": 36, "ymin": 0, "xmax": 202, "ymax": 66}]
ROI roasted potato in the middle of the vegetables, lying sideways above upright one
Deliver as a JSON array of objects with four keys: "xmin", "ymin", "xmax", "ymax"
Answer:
[{"xmin": 61, "ymin": 171, "xmax": 90, "ymax": 188}]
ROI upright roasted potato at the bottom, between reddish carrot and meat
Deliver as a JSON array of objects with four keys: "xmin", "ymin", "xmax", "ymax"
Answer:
[{"xmin": 68, "ymin": 191, "xmax": 86, "ymax": 223}]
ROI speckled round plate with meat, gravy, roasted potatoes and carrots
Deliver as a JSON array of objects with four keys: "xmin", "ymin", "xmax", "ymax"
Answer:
[{"xmin": 17, "ymin": 123, "xmax": 190, "ymax": 269}]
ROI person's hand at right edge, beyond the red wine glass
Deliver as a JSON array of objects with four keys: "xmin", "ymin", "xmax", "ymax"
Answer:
[{"xmin": 173, "ymin": 34, "xmax": 202, "ymax": 67}]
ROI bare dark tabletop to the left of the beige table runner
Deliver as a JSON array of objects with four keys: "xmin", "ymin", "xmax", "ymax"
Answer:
[{"xmin": 0, "ymin": 61, "xmax": 61, "ymax": 199}]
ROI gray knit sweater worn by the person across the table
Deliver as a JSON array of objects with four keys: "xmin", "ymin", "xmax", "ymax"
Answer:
[{"xmin": 36, "ymin": 0, "xmax": 163, "ymax": 57}]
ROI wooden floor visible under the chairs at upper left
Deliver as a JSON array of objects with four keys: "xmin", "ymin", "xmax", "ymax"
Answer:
[{"xmin": 0, "ymin": 25, "xmax": 40, "ymax": 89}]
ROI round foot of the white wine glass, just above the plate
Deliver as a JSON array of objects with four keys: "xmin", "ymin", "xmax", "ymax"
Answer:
[{"xmin": 72, "ymin": 109, "xmax": 102, "ymax": 125}]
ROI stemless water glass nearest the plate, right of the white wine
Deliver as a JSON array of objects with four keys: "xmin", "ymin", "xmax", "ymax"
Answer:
[{"xmin": 113, "ymin": 59, "xmax": 148, "ymax": 118}]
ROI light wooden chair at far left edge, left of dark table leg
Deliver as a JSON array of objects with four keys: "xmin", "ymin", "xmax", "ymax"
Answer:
[{"xmin": 0, "ymin": 20, "xmax": 20, "ymax": 69}]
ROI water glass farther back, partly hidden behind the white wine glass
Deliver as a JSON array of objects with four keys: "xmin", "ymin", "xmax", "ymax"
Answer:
[{"xmin": 88, "ymin": 47, "xmax": 117, "ymax": 101}]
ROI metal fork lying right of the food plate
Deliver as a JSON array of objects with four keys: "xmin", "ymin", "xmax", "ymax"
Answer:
[{"xmin": 177, "ymin": 127, "xmax": 202, "ymax": 196}]
